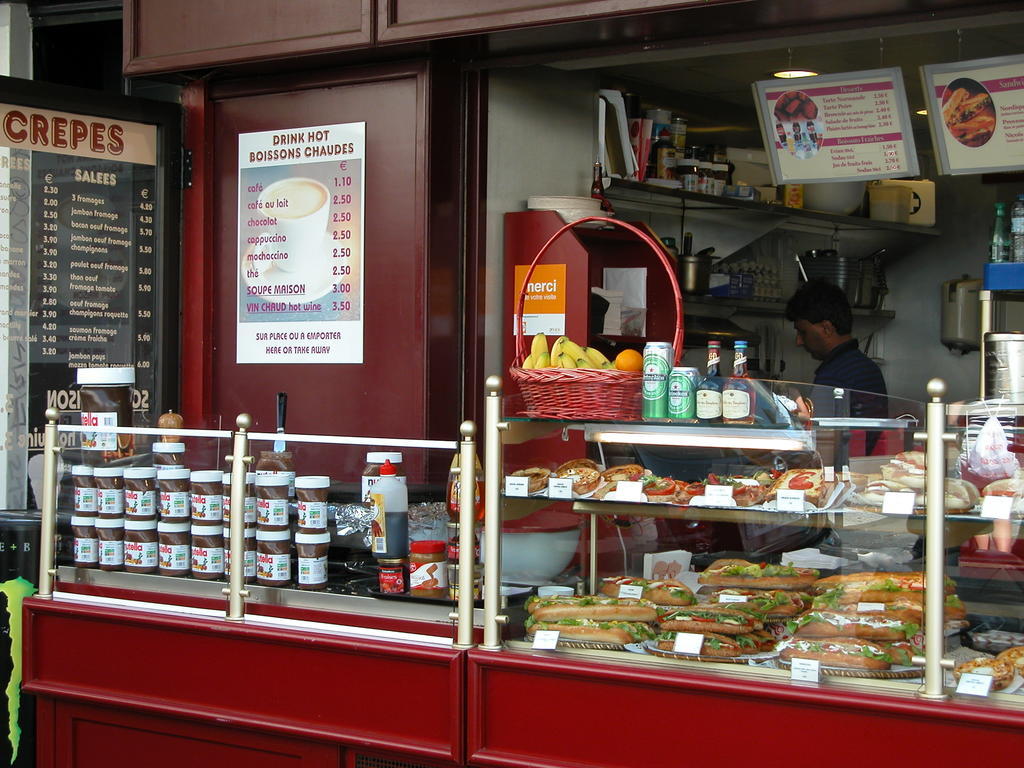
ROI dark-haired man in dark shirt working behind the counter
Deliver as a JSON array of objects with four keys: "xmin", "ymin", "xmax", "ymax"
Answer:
[{"xmin": 785, "ymin": 280, "xmax": 889, "ymax": 421}]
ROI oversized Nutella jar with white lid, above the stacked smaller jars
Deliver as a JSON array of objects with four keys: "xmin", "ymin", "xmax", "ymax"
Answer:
[{"xmin": 77, "ymin": 368, "xmax": 135, "ymax": 464}]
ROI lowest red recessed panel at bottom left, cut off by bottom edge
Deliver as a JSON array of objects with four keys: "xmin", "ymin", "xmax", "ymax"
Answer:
[{"xmin": 54, "ymin": 702, "xmax": 341, "ymax": 768}]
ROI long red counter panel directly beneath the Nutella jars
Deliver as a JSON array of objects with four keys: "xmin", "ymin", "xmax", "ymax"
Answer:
[{"xmin": 24, "ymin": 599, "xmax": 464, "ymax": 765}]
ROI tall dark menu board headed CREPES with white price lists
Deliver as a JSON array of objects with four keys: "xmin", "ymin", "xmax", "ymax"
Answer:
[{"xmin": 0, "ymin": 103, "xmax": 161, "ymax": 508}]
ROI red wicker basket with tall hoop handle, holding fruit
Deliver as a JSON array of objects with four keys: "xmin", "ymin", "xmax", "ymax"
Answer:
[{"xmin": 509, "ymin": 216, "xmax": 683, "ymax": 421}]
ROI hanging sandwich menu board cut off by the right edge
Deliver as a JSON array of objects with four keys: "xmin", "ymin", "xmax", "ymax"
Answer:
[{"xmin": 921, "ymin": 56, "xmax": 1024, "ymax": 174}]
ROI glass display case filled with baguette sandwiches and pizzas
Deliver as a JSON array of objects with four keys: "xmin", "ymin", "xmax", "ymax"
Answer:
[{"xmin": 483, "ymin": 378, "xmax": 1024, "ymax": 707}]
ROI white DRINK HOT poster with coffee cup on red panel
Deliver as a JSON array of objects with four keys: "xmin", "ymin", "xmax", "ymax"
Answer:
[{"xmin": 236, "ymin": 123, "xmax": 366, "ymax": 364}]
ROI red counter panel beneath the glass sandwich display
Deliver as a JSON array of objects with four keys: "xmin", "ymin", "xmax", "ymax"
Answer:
[{"xmin": 467, "ymin": 650, "xmax": 1024, "ymax": 768}]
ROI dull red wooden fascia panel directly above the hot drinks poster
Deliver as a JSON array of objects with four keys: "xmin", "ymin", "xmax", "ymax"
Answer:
[{"xmin": 124, "ymin": 0, "xmax": 374, "ymax": 75}]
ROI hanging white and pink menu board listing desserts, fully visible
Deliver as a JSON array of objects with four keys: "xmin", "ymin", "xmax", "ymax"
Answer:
[{"xmin": 754, "ymin": 68, "xmax": 918, "ymax": 184}]
